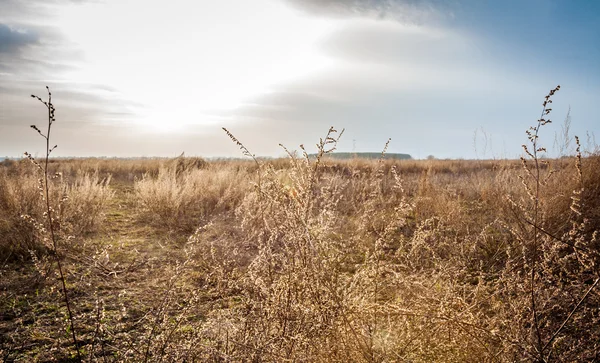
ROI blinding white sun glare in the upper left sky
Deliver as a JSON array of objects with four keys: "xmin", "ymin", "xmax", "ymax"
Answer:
[{"xmin": 58, "ymin": 0, "xmax": 335, "ymax": 132}]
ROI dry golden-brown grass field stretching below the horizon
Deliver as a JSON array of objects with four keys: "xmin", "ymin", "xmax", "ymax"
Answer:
[{"xmin": 0, "ymin": 88, "xmax": 600, "ymax": 362}]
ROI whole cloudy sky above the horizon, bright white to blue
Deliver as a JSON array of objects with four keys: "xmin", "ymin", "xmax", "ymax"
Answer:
[{"xmin": 0, "ymin": 0, "xmax": 600, "ymax": 159}]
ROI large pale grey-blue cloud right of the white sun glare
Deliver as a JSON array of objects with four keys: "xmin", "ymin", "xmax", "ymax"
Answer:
[{"xmin": 210, "ymin": 10, "xmax": 564, "ymax": 157}]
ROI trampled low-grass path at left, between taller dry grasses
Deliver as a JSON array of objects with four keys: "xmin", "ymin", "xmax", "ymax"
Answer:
[{"xmin": 0, "ymin": 183, "xmax": 196, "ymax": 362}]
